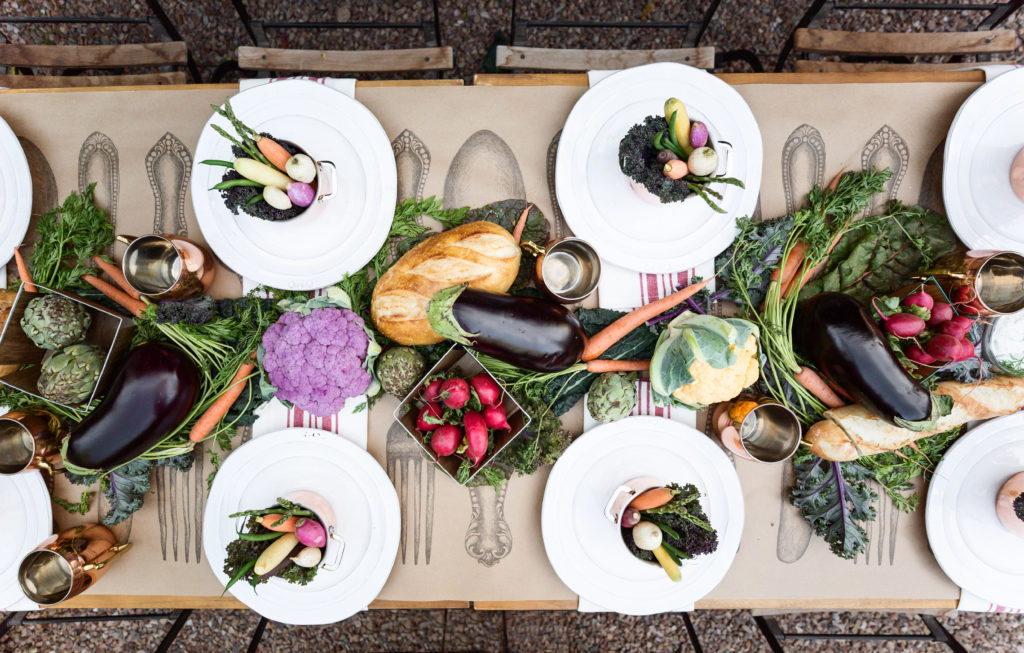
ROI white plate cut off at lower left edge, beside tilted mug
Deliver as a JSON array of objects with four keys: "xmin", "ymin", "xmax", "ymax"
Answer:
[{"xmin": 0, "ymin": 470, "xmax": 53, "ymax": 610}]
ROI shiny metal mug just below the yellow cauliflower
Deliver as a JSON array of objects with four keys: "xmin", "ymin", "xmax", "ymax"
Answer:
[{"xmin": 712, "ymin": 395, "xmax": 803, "ymax": 464}]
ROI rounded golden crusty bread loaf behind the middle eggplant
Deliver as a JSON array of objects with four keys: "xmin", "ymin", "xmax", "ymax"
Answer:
[{"xmin": 370, "ymin": 220, "xmax": 521, "ymax": 345}]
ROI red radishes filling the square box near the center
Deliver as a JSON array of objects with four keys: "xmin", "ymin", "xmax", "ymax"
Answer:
[{"xmin": 416, "ymin": 373, "xmax": 512, "ymax": 471}]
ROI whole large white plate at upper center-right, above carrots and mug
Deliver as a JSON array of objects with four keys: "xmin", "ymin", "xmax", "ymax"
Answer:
[{"xmin": 555, "ymin": 63, "xmax": 762, "ymax": 272}]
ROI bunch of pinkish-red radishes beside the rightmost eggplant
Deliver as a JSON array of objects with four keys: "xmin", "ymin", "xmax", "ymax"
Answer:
[{"xmin": 871, "ymin": 288, "xmax": 977, "ymax": 365}]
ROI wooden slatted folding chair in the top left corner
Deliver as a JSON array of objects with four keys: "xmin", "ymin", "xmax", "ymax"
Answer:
[{"xmin": 0, "ymin": 0, "xmax": 200, "ymax": 88}]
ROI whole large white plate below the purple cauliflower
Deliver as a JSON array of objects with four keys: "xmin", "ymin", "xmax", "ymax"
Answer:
[{"xmin": 203, "ymin": 429, "xmax": 401, "ymax": 624}]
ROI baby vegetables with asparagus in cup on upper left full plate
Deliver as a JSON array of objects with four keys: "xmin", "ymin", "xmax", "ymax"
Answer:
[{"xmin": 202, "ymin": 100, "xmax": 317, "ymax": 221}]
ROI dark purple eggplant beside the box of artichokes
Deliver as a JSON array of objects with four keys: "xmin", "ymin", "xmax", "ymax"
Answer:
[{"xmin": 66, "ymin": 343, "xmax": 199, "ymax": 471}]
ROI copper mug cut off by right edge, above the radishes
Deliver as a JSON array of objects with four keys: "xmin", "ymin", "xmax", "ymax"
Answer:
[{"xmin": 916, "ymin": 250, "xmax": 1024, "ymax": 315}]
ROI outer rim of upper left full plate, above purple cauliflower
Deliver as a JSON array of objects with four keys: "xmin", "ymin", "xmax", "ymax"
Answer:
[{"xmin": 190, "ymin": 80, "xmax": 398, "ymax": 291}]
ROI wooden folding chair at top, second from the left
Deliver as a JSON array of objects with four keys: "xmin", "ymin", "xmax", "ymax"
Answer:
[{"xmin": 214, "ymin": 0, "xmax": 455, "ymax": 81}]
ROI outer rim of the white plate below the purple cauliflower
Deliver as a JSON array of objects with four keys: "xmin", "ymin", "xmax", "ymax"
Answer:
[{"xmin": 203, "ymin": 428, "xmax": 401, "ymax": 625}]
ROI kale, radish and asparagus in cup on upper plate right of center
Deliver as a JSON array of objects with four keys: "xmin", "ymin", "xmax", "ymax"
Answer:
[{"xmin": 618, "ymin": 97, "xmax": 743, "ymax": 213}]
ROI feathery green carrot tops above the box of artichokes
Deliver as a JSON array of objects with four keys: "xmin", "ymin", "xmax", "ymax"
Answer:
[{"xmin": 29, "ymin": 183, "xmax": 114, "ymax": 290}]
